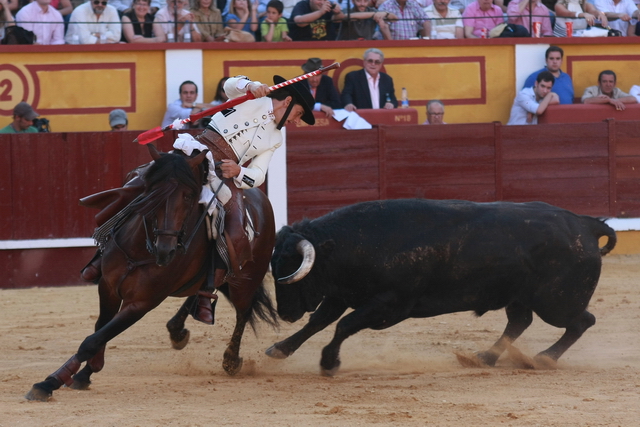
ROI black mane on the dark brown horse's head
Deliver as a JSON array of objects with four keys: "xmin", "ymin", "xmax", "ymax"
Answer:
[{"xmin": 131, "ymin": 152, "xmax": 202, "ymax": 215}]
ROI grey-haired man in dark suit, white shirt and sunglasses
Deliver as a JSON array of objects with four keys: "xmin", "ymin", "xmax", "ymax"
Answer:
[{"xmin": 342, "ymin": 48, "xmax": 398, "ymax": 111}]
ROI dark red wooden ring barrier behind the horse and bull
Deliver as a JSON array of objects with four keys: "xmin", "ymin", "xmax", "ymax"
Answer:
[{"xmin": 0, "ymin": 120, "xmax": 640, "ymax": 288}]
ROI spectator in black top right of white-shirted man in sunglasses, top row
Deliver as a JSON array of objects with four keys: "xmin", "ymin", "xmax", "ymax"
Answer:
[{"xmin": 122, "ymin": 0, "xmax": 167, "ymax": 43}]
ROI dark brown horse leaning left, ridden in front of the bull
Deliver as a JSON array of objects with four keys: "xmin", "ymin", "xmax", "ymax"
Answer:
[{"xmin": 25, "ymin": 144, "xmax": 276, "ymax": 401}]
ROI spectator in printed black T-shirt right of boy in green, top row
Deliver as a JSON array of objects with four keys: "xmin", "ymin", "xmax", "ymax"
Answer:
[{"xmin": 289, "ymin": 0, "xmax": 344, "ymax": 41}]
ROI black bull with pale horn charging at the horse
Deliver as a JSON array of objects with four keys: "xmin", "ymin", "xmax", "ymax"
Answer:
[{"xmin": 267, "ymin": 200, "xmax": 616, "ymax": 375}]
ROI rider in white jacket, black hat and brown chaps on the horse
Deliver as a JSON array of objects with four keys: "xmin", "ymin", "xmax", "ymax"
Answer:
[{"xmin": 81, "ymin": 76, "xmax": 315, "ymax": 324}]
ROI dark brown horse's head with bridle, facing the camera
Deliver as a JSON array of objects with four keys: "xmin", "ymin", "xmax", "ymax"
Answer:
[{"xmin": 134, "ymin": 144, "xmax": 207, "ymax": 267}]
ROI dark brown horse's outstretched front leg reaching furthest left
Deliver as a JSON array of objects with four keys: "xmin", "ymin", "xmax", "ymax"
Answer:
[{"xmin": 25, "ymin": 298, "xmax": 164, "ymax": 401}]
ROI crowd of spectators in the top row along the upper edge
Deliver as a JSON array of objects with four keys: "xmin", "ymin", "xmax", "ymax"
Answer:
[{"xmin": 0, "ymin": 0, "xmax": 640, "ymax": 44}]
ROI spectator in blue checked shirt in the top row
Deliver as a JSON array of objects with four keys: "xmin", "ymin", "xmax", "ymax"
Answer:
[{"xmin": 378, "ymin": 0, "xmax": 431, "ymax": 40}]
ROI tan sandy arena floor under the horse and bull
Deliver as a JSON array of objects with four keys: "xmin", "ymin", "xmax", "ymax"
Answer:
[{"xmin": 0, "ymin": 255, "xmax": 640, "ymax": 427}]
